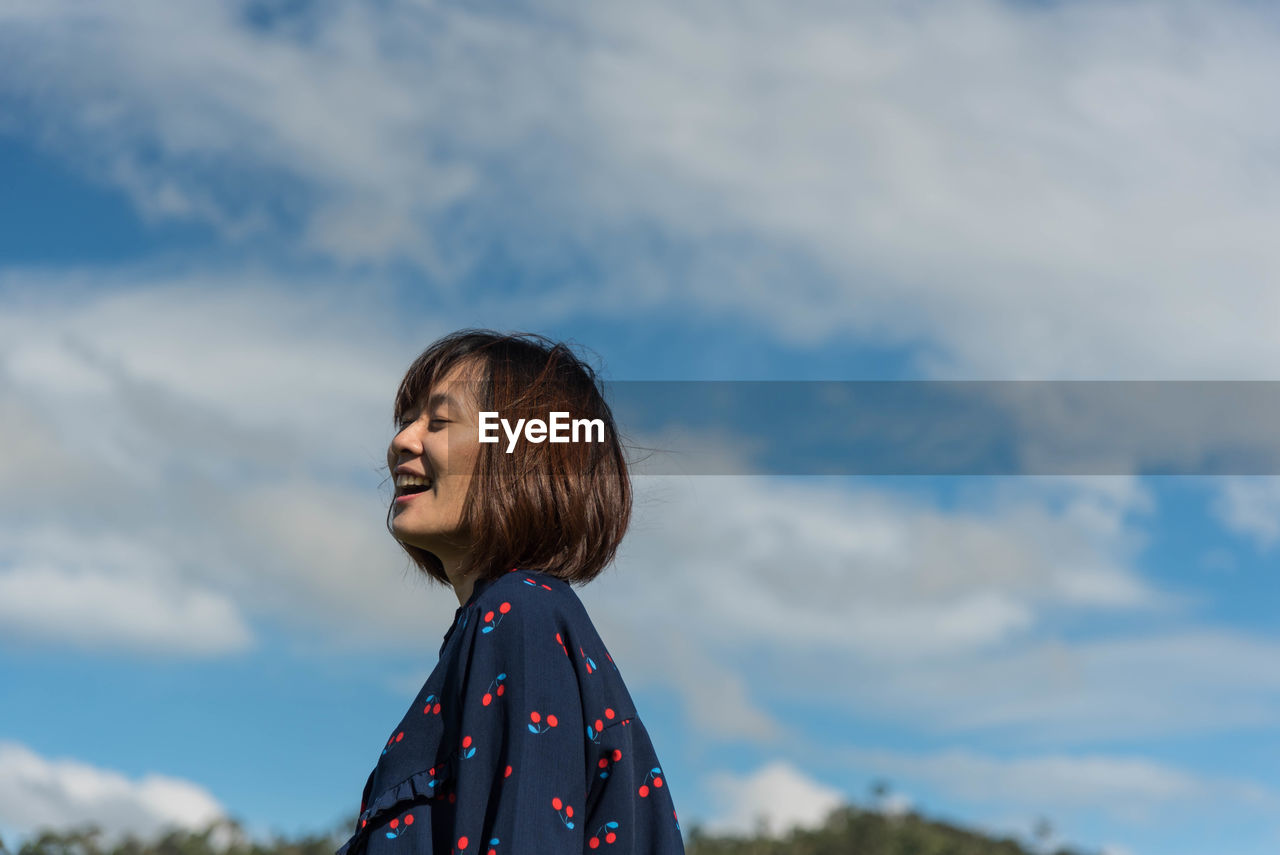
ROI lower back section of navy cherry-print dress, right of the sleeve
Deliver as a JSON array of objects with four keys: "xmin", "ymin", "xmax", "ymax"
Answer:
[{"xmin": 584, "ymin": 718, "xmax": 685, "ymax": 855}]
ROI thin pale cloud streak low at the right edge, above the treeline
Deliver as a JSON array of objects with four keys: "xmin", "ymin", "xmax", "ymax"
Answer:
[{"xmin": 793, "ymin": 627, "xmax": 1280, "ymax": 745}]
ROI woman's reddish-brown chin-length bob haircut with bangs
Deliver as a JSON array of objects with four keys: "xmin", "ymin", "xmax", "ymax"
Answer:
[{"xmin": 387, "ymin": 329, "xmax": 631, "ymax": 585}]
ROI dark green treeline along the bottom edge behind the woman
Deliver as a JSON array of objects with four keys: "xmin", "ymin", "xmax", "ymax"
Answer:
[{"xmin": 0, "ymin": 805, "xmax": 1092, "ymax": 855}]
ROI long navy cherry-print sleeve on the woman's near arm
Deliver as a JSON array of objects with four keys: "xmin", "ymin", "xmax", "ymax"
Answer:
[{"xmin": 448, "ymin": 587, "xmax": 586, "ymax": 855}]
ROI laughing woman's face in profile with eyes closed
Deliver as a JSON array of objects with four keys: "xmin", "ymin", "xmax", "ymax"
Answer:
[{"xmin": 387, "ymin": 364, "xmax": 480, "ymax": 570}]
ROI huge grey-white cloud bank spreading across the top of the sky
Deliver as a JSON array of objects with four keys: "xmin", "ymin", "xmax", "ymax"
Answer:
[{"xmin": 0, "ymin": 0, "xmax": 1280, "ymax": 379}]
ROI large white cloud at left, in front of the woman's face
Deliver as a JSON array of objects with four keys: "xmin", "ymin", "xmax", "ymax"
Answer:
[{"xmin": 0, "ymin": 280, "xmax": 473, "ymax": 655}]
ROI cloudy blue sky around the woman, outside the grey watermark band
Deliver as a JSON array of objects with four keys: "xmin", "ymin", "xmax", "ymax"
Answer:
[{"xmin": 0, "ymin": 0, "xmax": 1280, "ymax": 855}]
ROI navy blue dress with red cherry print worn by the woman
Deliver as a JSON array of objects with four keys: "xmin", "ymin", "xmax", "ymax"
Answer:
[{"xmin": 338, "ymin": 568, "xmax": 685, "ymax": 855}]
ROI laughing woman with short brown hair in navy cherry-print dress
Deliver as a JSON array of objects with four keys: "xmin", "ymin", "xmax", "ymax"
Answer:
[{"xmin": 338, "ymin": 330, "xmax": 685, "ymax": 855}]
